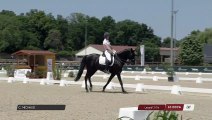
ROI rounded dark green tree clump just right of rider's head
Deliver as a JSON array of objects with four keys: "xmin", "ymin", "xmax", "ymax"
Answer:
[{"xmin": 112, "ymin": 20, "xmax": 161, "ymax": 46}]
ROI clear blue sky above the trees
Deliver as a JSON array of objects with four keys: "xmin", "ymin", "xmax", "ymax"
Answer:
[{"xmin": 0, "ymin": 0, "xmax": 212, "ymax": 39}]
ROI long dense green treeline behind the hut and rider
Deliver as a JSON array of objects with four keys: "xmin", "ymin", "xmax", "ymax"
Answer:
[{"xmin": 0, "ymin": 9, "xmax": 164, "ymax": 57}]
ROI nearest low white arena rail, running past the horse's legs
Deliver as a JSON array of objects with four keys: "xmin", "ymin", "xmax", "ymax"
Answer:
[{"xmin": 0, "ymin": 77, "xmax": 212, "ymax": 95}]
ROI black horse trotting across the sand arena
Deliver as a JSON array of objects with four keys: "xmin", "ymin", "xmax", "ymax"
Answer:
[{"xmin": 74, "ymin": 48, "xmax": 135, "ymax": 93}]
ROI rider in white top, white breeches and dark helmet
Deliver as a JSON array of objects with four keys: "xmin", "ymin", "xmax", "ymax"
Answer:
[{"xmin": 103, "ymin": 32, "xmax": 116, "ymax": 74}]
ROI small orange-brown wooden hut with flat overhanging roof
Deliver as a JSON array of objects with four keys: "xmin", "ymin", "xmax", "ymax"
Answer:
[{"xmin": 12, "ymin": 50, "xmax": 55, "ymax": 77}]
